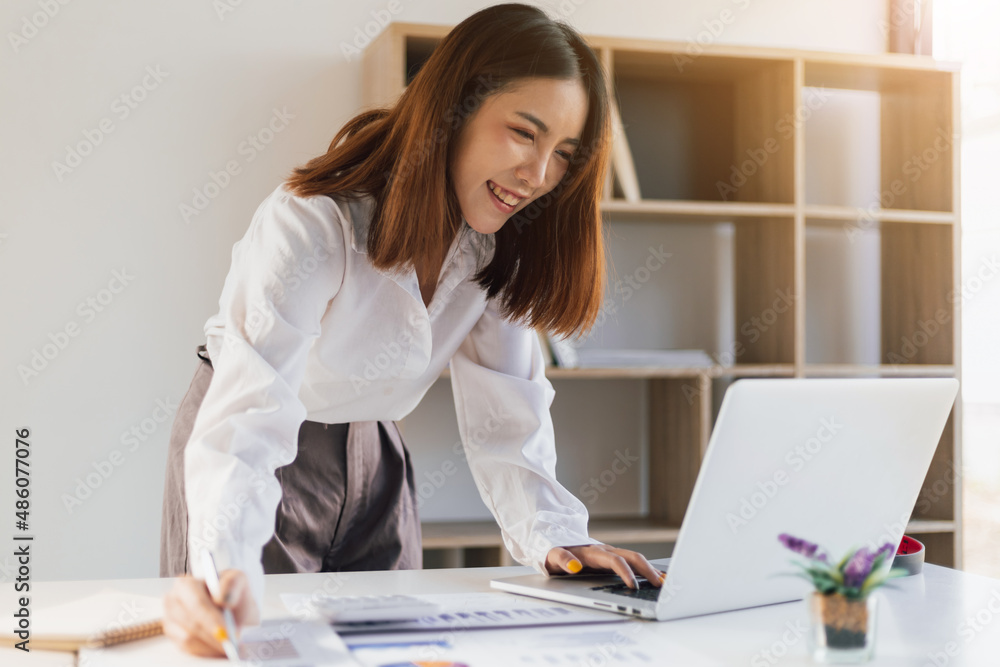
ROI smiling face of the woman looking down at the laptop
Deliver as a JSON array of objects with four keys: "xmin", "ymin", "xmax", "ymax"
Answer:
[{"xmin": 449, "ymin": 78, "xmax": 587, "ymax": 234}]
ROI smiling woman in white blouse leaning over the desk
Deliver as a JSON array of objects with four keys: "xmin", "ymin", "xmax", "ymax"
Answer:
[{"xmin": 161, "ymin": 4, "xmax": 662, "ymax": 655}]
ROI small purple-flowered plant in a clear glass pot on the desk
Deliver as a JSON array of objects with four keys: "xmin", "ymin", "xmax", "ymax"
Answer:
[{"xmin": 778, "ymin": 533, "xmax": 906, "ymax": 662}]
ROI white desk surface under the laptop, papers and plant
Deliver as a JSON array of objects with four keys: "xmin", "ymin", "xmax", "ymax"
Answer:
[{"xmin": 0, "ymin": 565, "xmax": 1000, "ymax": 667}]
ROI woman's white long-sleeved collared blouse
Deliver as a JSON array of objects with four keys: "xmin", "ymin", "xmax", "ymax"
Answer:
[{"xmin": 184, "ymin": 183, "xmax": 598, "ymax": 608}]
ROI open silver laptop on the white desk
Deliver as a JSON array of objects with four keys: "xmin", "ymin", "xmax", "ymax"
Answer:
[{"xmin": 491, "ymin": 378, "xmax": 958, "ymax": 621}]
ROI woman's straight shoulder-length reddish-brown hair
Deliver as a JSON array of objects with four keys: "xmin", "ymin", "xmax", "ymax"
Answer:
[{"xmin": 288, "ymin": 3, "xmax": 611, "ymax": 335}]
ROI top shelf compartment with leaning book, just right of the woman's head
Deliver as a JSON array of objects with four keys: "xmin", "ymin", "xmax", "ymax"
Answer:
[{"xmin": 611, "ymin": 49, "xmax": 795, "ymax": 204}]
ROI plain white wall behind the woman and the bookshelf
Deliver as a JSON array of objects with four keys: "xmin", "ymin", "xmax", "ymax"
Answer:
[{"xmin": 0, "ymin": 0, "xmax": 885, "ymax": 580}]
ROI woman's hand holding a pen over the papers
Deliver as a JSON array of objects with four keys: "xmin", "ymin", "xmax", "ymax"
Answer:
[{"xmin": 163, "ymin": 569, "xmax": 260, "ymax": 657}]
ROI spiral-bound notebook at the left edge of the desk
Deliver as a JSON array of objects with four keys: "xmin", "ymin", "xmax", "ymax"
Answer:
[{"xmin": 0, "ymin": 588, "xmax": 163, "ymax": 651}]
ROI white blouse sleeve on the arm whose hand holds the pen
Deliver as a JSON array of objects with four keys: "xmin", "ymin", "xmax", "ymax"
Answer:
[{"xmin": 184, "ymin": 189, "xmax": 346, "ymax": 609}]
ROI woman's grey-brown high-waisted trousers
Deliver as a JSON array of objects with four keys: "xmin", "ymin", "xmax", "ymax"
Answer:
[{"xmin": 160, "ymin": 345, "xmax": 423, "ymax": 577}]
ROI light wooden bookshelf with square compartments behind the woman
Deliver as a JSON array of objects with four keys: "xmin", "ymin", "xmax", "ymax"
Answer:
[{"xmin": 362, "ymin": 23, "xmax": 962, "ymax": 567}]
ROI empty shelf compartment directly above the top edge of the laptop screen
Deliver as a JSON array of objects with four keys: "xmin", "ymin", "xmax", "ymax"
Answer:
[{"xmin": 805, "ymin": 219, "xmax": 957, "ymax": 368}]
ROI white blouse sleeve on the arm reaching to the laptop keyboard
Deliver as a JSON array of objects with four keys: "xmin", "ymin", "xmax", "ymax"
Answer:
[{"xmin": 451, "ymin": 299, "xmax": 600, "ymax": 576}]
